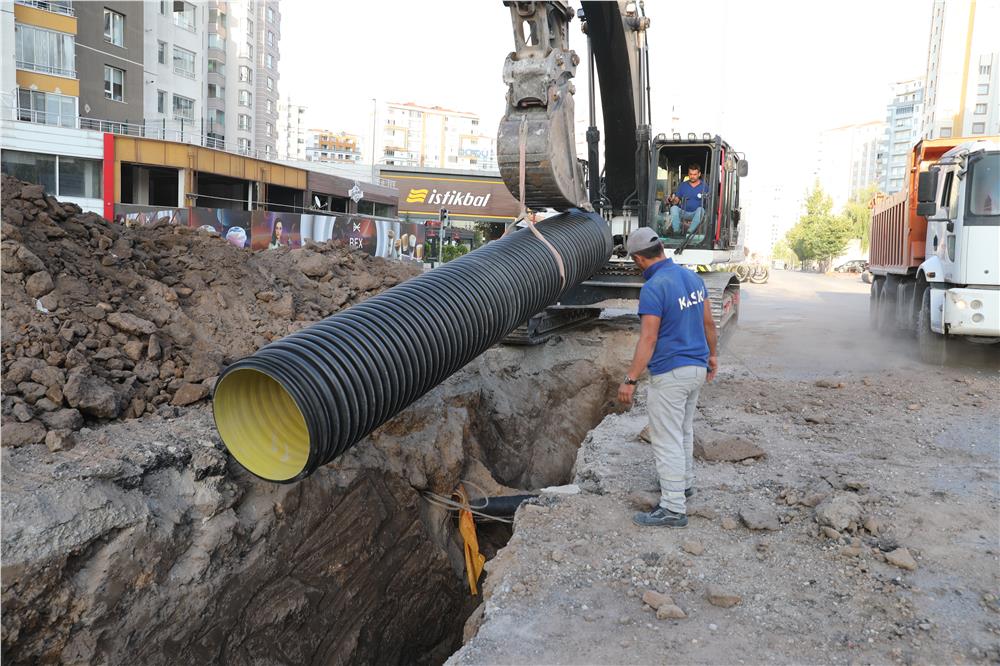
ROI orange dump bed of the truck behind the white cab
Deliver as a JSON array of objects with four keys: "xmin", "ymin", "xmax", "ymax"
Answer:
[{"xmin": 868, "ymin": 137, "xmax": 968, "ymax": 275}]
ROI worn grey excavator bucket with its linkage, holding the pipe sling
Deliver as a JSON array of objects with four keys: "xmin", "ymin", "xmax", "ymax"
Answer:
[{"xmin": 497, "ymin": 2, "xmax": 591, "ymax": 210}]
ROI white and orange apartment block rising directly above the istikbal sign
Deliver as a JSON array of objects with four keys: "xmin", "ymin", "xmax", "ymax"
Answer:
[{"xmin": 379, "ymin": 102, "xmax": 497, "ymax": 171}]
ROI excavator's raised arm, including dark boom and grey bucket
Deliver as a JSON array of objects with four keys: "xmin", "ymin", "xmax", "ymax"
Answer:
[{"xmin": 497, "ymin": 0, "xmax": 649, "ymax": 214}]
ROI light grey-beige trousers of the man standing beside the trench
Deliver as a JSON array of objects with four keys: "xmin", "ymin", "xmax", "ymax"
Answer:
[{"xmin": 646, "ymin": 365, "xmax": 707, "ymax": 513}]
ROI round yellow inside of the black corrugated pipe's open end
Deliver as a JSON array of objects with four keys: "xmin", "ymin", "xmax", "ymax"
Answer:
[{"xmin": 213, "ymin": 368, "xmax": 309, "ymax": 481}]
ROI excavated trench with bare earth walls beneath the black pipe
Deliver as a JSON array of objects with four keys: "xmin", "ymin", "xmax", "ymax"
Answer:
[{"xmin": 3, "ymin": 321, "xmax": 633, "ymax": 664}]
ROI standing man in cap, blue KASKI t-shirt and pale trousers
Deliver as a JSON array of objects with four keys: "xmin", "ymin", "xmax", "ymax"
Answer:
[{"xmin": 618, "ymin": 227, "xmax": 719, "ymax": 527}]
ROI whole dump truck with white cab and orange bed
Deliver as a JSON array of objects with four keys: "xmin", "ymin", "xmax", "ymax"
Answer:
[{"xmin": 869, "ymin": 137, "xmax": 1000, "ymax": 365}]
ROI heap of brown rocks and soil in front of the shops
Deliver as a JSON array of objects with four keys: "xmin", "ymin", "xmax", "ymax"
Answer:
[{"xmin": 2, "ymin": 175, "xmax": 420, "ymax": 450}]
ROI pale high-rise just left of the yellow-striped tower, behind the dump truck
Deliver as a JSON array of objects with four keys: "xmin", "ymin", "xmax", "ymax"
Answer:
[{"xmin": 878, "ymin": 79, "xmax": 924, "ymax": 194}]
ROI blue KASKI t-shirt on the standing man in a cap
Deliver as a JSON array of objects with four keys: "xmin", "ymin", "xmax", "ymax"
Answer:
[{"xmin": 639, "ymin": 259, "xmax": 710, "ymax": 375}]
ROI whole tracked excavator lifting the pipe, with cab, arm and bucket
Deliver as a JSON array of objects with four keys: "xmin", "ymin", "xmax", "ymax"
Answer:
[{"xmin": 497, "ymin": 0, "xmax": 748, "ymax": 344}]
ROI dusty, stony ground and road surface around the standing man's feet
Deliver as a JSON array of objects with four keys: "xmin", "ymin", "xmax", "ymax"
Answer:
[{"xmin": 451, "ymin": 271, "xmax": 1000, "ymax": 664}]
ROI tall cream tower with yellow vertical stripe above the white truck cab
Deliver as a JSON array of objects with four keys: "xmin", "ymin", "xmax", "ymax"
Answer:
[{"xmin": 923, "ymin": 0, "xmax": 1000, "ymax": 139}]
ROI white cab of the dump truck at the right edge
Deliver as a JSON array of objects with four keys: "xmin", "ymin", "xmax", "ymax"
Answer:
[{"xmin": 917, "ymin": 141, "xmax": 1000, "ymax": 342}]
